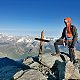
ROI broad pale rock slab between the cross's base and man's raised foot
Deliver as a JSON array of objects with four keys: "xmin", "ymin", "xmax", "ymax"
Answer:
[{"xmin": 40, "ymin": 53, "xmax": 63, "ymax": 68}]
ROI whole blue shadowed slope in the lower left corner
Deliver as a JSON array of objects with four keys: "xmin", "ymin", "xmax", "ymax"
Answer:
[{"xmin": 0, "ymin": 57, "xmax": 30, "ymax": 80}]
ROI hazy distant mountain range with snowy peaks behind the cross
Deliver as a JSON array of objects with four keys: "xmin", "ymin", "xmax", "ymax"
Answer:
[{"xmin": 0, "ymin": 33, "xmax": 80, "ymax": 59}]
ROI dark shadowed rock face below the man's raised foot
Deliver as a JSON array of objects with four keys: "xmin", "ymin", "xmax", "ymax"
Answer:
[{"xmin": 48, "ymin": 60, "xmax": 66, "ymax": 80}]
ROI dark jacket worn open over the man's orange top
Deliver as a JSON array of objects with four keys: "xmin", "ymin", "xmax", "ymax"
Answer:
[{"xmin": 61, "ymin": 25, "xmax": 78, "ymax": 46}]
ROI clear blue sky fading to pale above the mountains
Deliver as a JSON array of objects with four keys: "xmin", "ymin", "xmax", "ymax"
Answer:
[{"xmin": 0, "ymin": 0, "xmax": 80, "ymax": 37}]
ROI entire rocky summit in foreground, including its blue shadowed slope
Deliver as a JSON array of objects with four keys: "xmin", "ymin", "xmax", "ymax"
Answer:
[{"xmin": 0, "ymin": 51, "xmax": 80, "ymax": 80}]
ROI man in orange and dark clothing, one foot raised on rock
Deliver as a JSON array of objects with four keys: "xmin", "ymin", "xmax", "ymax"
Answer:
[{"xmin": 54, "ymin": 18, "xmax": 78, "ymax": 63}]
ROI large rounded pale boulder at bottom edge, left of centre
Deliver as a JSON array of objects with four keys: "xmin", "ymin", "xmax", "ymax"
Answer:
[{"xmin": 17, "ymin": 69, "xmax": 47, "ymax": 80}]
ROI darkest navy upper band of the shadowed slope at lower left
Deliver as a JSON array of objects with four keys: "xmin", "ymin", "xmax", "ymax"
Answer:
[{"xmin": 0, "ymin": 57, "xmax": 30, "ymax": 70}]
